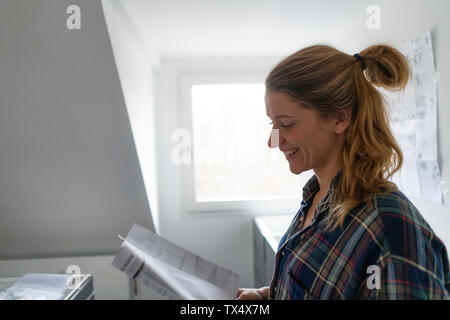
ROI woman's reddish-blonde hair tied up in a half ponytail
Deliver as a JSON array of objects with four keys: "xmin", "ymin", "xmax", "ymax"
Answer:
[{"xmin": 265, "ymin": 44, "xmax": 411, "ymax": 229}]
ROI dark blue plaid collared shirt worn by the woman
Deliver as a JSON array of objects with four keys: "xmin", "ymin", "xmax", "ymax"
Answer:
[{"xmin": 269, "ymin": 173, "xmax": 450, "ymax": 300}]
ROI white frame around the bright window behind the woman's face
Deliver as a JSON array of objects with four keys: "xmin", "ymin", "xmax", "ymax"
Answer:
[{"xmin": 179, "ymin": 72, "xmax": 302, "ymax": 215}]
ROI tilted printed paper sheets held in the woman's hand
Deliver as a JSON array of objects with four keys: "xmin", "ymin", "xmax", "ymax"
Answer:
[{"xmin": 112, "ymin": 224, "xmax": 239, "ymax": 300}]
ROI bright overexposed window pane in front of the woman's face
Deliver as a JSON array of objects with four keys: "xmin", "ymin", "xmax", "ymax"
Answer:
[{"xmin": 191, "ymin": 83, "xmax": 310, "ymax": 201}]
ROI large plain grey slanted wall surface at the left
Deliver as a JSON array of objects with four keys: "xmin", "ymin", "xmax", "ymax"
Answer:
[{"xmin": 0, "ymin": 0, "xmax": 153, "ymax": 259}]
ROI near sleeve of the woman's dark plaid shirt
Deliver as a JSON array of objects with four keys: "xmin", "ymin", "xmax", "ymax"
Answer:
[{"xmin": 368, "ymin": 191, "xmax": 450, "ymax": 300}]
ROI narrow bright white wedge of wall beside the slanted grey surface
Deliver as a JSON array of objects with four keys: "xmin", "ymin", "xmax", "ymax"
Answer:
[{"xmin": 102, "ymin": 0, "xmax": 159, "ymax": 235}]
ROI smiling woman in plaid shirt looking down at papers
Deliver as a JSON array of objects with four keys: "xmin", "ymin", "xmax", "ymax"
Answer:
[{"xmin": 237, "ymin": 45, "xmax": 450, "ymax": 299}]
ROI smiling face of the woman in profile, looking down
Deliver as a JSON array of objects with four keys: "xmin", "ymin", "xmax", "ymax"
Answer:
[{"xmin": 264, "ymin": 91, "xmax": 348, "ymax": 174}]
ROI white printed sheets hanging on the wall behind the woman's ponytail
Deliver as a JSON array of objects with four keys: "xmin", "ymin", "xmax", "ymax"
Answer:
[{"xmin": 380, "ymin": 31, "xmax": 443, "ymax": 203}]
